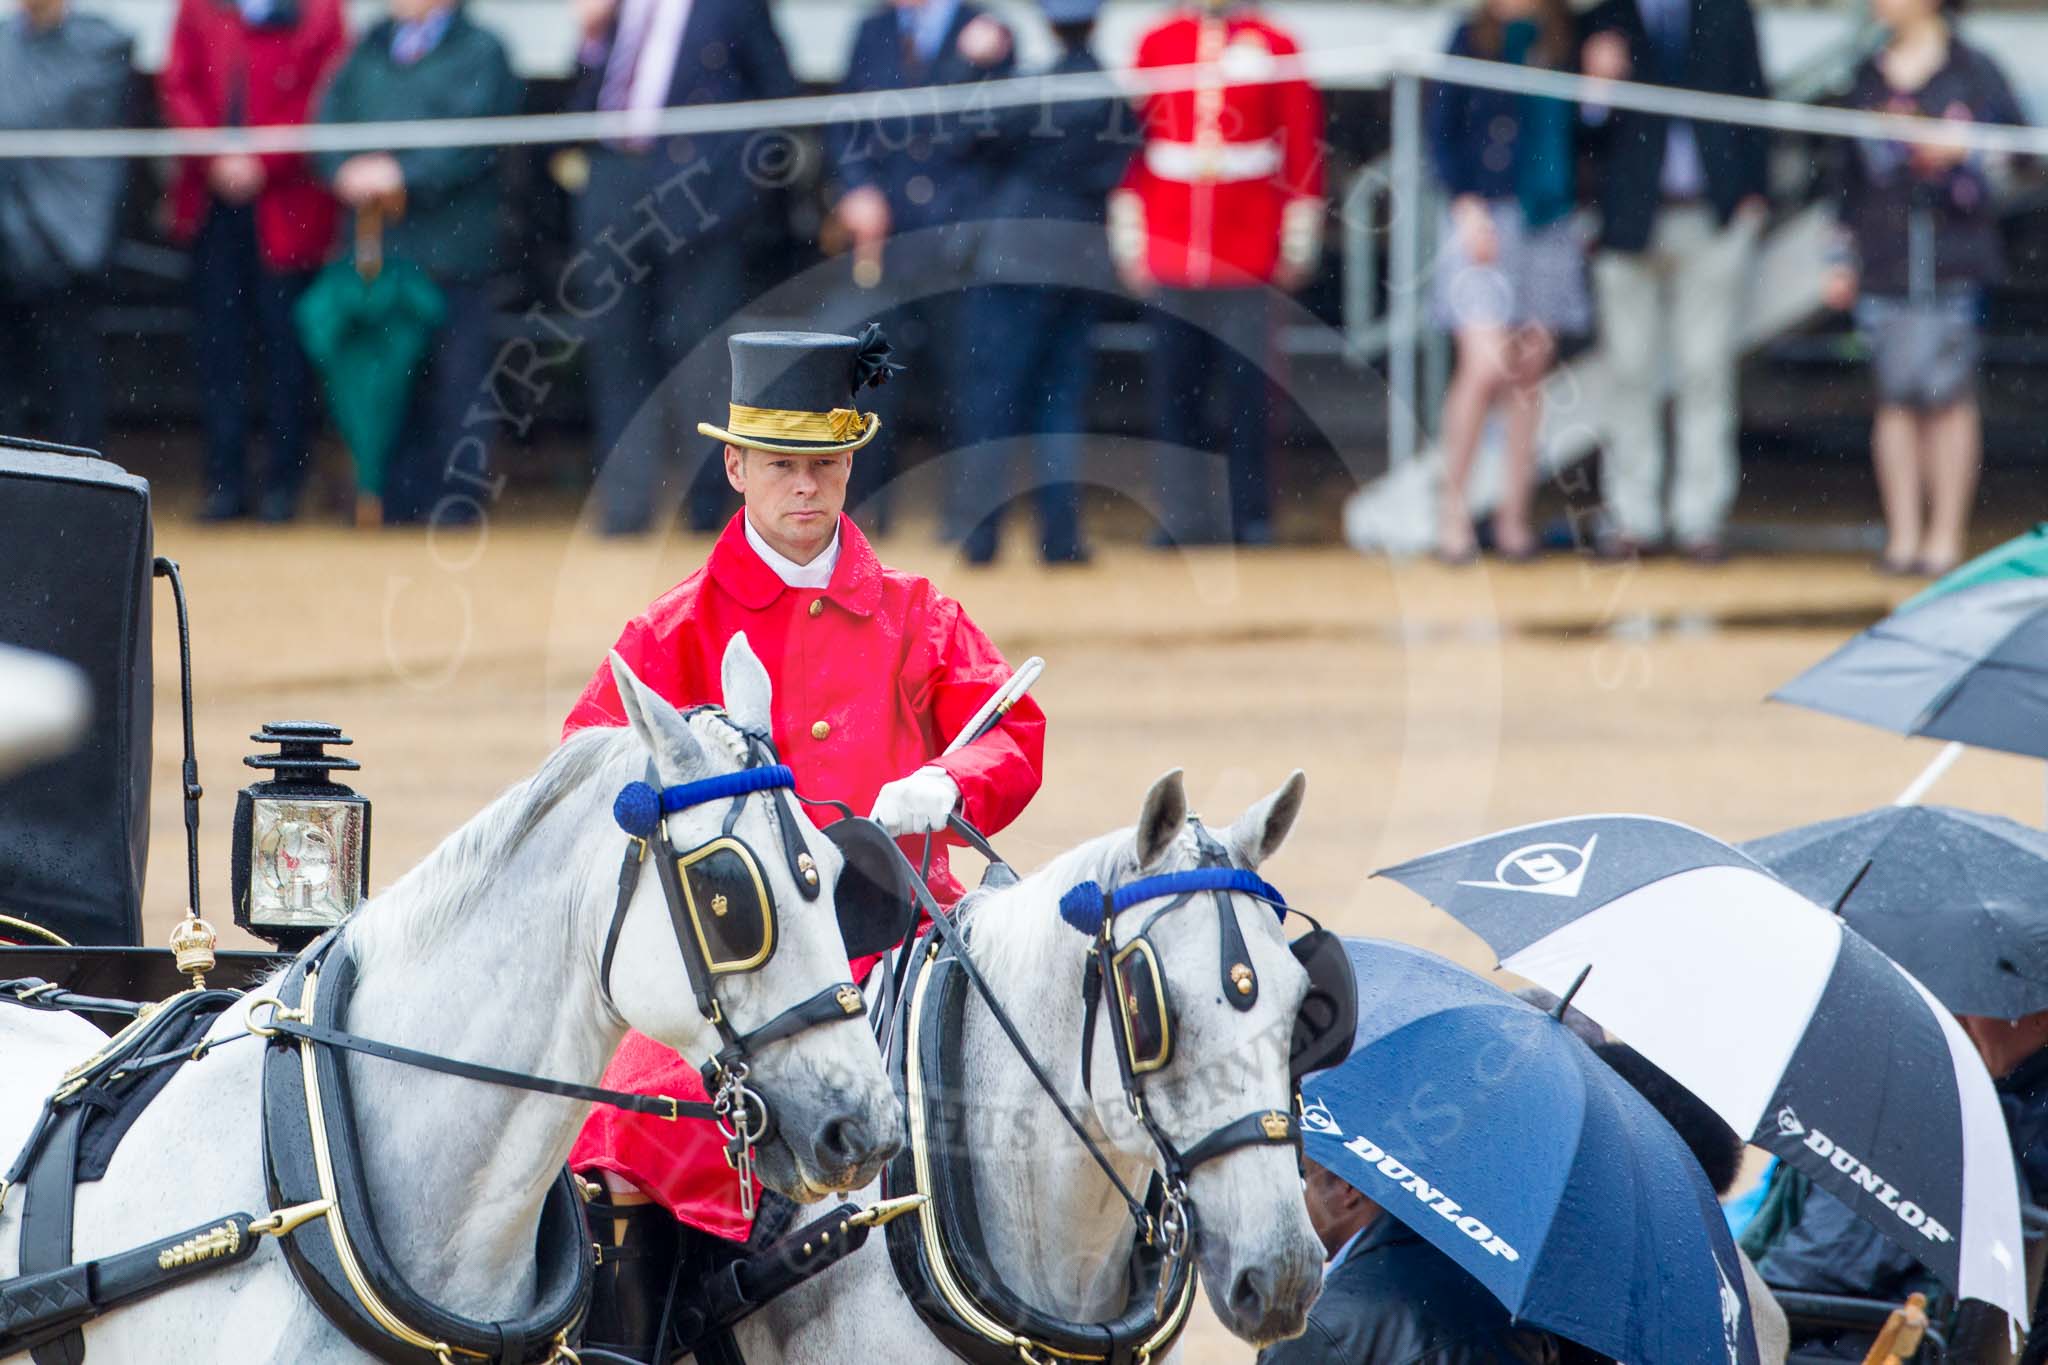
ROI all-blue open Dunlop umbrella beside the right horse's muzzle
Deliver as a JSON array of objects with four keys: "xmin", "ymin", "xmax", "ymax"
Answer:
[{"xmin": 1300, "ymin": 939, "xmax": 1757, "ymax": 1365}]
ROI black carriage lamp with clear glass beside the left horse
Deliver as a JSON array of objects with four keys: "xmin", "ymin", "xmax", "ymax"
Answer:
[{"xmin": 233, "ymin": 720, "xmax": 371, "ymax": 952}]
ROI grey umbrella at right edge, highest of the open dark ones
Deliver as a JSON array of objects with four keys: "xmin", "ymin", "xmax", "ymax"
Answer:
[{"xmin": 1772, "ymin": 579, "xmax": 2048, "ymax": 759}]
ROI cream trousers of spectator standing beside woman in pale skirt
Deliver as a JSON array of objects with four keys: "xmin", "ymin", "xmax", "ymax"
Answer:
[{"xmin": 1593, "ymin": 205, "xmax": 1759, "ymax": 546}]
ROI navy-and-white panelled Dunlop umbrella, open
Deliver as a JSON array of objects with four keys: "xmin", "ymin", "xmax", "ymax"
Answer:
[{"xmin": 1362, "ymin": 814, "xmax": 2028, "ymax": 1322}]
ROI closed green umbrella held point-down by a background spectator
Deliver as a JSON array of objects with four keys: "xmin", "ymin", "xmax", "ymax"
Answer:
[{"xmin": 295, "ymin": 215, "xmax": 449, "ymax": 497}]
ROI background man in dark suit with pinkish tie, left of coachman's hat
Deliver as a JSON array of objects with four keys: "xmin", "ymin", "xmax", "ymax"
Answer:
[{"xmin": 571, "ymin": 0, "xmax": 797, "ymax": 536}]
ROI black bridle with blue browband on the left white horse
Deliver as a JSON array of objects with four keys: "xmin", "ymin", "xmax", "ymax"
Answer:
[{"xmin": 598, "ymin": 706, "xmax": 866, "ymax": 1218}]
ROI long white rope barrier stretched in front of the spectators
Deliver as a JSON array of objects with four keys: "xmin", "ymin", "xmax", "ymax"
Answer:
[{"xmin": 0, "ymin": 45, "xmax": 2048, "ymax": 160}]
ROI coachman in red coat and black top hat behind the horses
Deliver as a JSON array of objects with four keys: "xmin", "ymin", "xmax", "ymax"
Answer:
[{"xmin": 563, "ymin": 325, "xmax": 1044, "ymax": 1359}]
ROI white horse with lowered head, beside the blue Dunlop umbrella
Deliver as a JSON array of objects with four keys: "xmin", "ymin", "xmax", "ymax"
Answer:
[{"xmin": 735, "ymin": 772, "xmax": 1323, "ymax": 1365}]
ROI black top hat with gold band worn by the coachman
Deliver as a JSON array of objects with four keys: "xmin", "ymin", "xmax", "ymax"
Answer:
[{"xmin": 696, "ymin": 323, "xmax": 903, "ymax": 454}]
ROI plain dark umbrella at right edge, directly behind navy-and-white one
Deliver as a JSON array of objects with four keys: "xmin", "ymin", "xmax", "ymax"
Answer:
[{"xmin": 1743, "ymin": 806, "xmax": 2048, "ymax": 1019}]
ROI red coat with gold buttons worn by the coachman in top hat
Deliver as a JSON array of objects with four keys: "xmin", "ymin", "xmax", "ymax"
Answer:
[{"xmin": 563, "ymin": 512, "xmax": 1044, "ymax": 1240}]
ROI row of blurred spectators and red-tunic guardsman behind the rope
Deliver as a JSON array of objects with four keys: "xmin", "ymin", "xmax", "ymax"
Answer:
[{"xmin": 0, "ymin": 0, "xmax": 2021, "ymax": 573}]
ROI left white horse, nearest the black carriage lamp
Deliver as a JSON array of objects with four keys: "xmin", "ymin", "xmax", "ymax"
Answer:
[{"xmin": 0, "ymin": 636, "xmax": 903, "ymax": 1365}]
